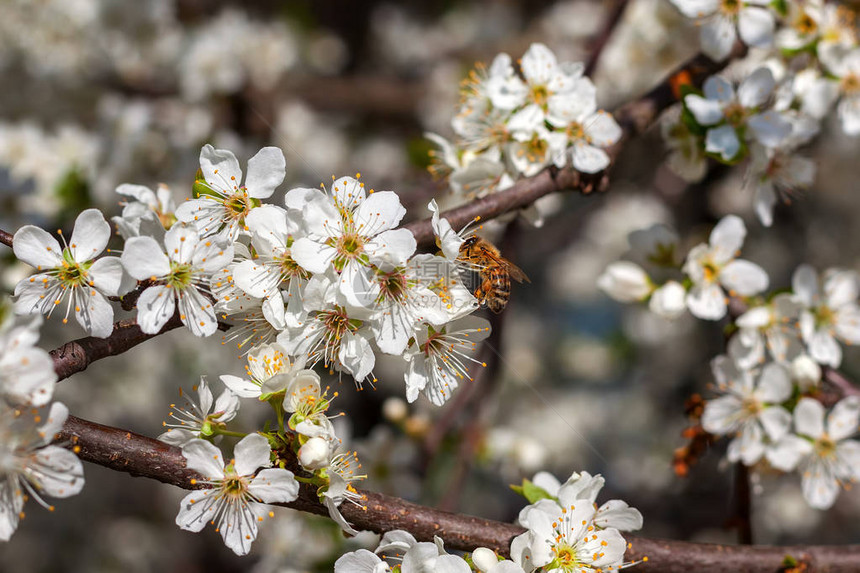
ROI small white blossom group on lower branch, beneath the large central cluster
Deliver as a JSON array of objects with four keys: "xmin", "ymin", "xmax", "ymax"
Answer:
[{"xmin": 166, "ymin": 344, "xmax": 364, "ymax": 555}]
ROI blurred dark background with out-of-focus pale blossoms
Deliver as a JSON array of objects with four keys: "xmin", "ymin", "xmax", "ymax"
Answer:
[{"xmin": 0, "ymin": 0, "xmax": 860, "ymax": 573}]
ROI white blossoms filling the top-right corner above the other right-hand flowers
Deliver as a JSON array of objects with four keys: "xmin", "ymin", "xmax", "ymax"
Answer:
[{"xmin": 663, "ymin": 0, "xmax": 860, "ymax": 226}]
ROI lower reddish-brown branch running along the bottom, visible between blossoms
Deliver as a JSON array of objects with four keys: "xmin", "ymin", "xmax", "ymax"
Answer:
[{"xmin": 58, "ymin": 416, "xmax": 860, "ymax": 573}]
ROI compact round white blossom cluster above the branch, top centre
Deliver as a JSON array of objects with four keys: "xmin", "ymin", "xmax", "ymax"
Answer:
[{"xmin": 427, "ymin": 44, "xmax": 621, "ymax": 217}]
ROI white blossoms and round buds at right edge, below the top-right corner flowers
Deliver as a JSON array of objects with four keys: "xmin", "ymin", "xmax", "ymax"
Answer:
[{"xmin": 599, "ymin": 216, "xmax": 860, "ymax": 509}]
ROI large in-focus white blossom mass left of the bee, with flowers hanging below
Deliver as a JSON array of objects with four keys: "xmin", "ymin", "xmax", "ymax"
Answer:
[{"xmin": 3, "ymin": 141, "xmax": 512, "ymax": 554}]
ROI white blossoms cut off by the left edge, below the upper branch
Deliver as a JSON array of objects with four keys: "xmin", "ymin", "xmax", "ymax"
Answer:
[{"xmin": 0, "ymin": 303, "xmax": 84, "ymax": 541}]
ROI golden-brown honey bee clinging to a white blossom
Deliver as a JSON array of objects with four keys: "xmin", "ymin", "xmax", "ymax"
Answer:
[{"xmin": 457, "ymin": 235, "xmax": 531, "ymax": 314}]
